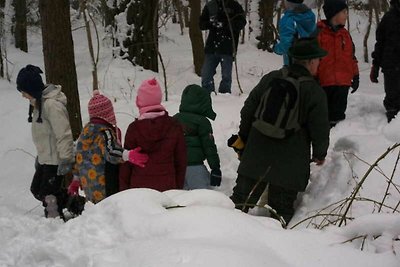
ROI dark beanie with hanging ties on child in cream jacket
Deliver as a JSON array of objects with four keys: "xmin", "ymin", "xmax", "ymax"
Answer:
[{"xmin": 17, "ymin": 65, "xmax": 44, "ymax": 122}]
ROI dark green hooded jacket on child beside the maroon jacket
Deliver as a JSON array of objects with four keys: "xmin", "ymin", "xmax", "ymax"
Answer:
[{"xmin": 174, "ymin": 85, "xmax": 220, "ymax": 169}]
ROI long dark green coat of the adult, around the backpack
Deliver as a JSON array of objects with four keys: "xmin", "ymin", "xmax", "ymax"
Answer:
[{"xmin": 238, "ymin": 65, "xmax": 329, "ymax": 191}]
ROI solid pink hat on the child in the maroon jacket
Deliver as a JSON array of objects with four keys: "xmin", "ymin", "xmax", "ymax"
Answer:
[{"xmin": 136, "ymin": 78, "xmax": 165, "ymax": 115}]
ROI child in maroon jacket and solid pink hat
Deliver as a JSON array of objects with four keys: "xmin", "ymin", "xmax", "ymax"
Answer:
[{"xmin": 119, "ymin": 78, "xmax": 187, "ymax": 191}]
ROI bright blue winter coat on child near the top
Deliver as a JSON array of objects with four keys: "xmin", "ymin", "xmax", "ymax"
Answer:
[{"xmin": 274, "ymin": 4, "xmax": 316, "ymax": 65}]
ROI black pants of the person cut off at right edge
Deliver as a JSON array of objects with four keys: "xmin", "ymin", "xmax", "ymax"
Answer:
[{"xmin": 383, "ymin": 70, "xmax": 400, "ymax": 122}]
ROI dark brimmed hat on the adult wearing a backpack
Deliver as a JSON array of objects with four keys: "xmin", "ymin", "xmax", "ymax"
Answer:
[{"xmin": 288, "ymin": 38, "xmax": 328, "ymax": 59}]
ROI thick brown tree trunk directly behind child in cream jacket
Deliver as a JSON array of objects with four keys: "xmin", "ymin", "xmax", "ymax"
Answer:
[{"xmin": 39, "ymin": 0, "xmax": 82, "ymax": 139}]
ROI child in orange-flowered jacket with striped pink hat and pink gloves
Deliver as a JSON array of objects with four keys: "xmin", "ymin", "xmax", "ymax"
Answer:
[{"xmin": 68, "ymin": 90, "xmax": 148, "ymax": 203}]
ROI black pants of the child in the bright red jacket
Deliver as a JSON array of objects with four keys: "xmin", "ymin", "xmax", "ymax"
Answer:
[{"xmin": 323, "ymin": 86, "xmax": 349, "ymax": 126}]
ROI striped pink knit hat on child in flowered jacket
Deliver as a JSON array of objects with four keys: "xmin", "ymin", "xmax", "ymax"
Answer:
[{"xmin": 88, "ymin": 90, "xmax": 117, "ymax": 126}]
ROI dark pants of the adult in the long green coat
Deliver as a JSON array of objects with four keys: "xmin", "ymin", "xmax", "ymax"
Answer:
[{"xmin": 231, "ymin": 174, "xmax": 298, "ymax": 223}]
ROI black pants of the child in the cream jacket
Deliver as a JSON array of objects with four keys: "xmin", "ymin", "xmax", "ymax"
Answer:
[{"xmin": 31, "ymin": 164, "xmax": 68, "ymax": 215}]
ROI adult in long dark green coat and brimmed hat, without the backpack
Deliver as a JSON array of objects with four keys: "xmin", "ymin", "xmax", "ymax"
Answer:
[{"xmin": 231, "ymin": 39, "xmax": 329, "ymax": 223}]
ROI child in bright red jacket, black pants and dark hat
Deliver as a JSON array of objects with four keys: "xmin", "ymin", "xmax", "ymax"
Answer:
[{"xmin": 317, "ymin": 0, "xmax": 360, "ymax": 127}]
